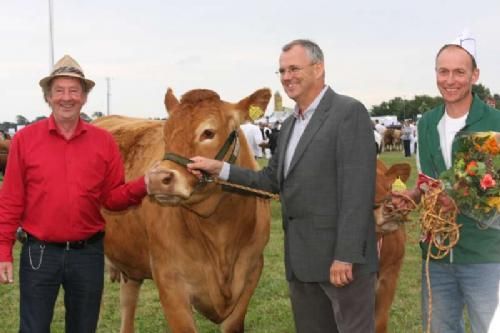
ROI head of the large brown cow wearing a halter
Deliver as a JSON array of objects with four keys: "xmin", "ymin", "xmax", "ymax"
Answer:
[{"xmin": 146, "ymin": 89, "xmax": 271, "ymax": 213}]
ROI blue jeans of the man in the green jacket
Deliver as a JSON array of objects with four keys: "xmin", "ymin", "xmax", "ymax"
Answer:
[{"xmin": 422, "ymin": 261, "xmax": 500, "ymax": 333}]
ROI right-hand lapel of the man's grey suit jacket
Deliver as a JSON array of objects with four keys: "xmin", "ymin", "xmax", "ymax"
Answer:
[{"xmin": 287, "ymin": 88, "xmax": 335, "ymax": 173}]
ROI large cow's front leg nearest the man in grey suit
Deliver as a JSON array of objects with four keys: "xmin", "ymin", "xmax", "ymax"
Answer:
[{"xmin": 221, "ymin": 256, "xmax": 264, "ymax": 333}]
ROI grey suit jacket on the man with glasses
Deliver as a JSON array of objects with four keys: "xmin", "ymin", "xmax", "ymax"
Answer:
[{"xmin": 229, "ymin": 88, "xmax": 378, "ymax": 282}]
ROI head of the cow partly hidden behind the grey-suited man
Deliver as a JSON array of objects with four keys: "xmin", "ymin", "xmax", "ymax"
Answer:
[{"xmin": 374, "ymin": 160, "xmax": 411, "ymax": 232}]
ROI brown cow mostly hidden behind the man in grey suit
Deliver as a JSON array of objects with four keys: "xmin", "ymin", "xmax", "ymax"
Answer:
[{"xmin": 374, "ymin": 160, "xmax": 411, "ymax": 333}]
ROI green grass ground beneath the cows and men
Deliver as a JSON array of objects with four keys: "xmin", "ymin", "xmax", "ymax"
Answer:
[{"xmin": 0, "ymin": 152, "xmax": 421, "ymax": 333}]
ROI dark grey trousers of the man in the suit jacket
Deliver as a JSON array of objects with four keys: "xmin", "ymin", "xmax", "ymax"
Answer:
[{"xmin": 288, "ymin": 273, "xmax": 375, "ymax": 333}]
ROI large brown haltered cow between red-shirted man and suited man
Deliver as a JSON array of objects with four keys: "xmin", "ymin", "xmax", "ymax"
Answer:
[{"xmin": 95, "ymin": 89, "xmax": 271, "ymax": 333}]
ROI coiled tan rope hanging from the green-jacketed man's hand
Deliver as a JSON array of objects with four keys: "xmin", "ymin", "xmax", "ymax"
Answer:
[{"xmin": 420, "ymin": 186, "xmax": 461, "ymax": 333}]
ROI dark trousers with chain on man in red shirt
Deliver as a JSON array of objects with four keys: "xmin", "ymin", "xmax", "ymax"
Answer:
[{"xmin": 19, "ymin": 239, "xmax": 104, "ymax": 333}]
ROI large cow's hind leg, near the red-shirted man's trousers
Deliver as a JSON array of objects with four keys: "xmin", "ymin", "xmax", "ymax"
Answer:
[{"xmin": 120, "ymin": 277, "xmax": 142, "ymax": 333}]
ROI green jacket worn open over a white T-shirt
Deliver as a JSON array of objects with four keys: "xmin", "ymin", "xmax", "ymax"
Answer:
[{"xmin": 418, "ymin": 95, "xmax": 500, "ymax": 264}]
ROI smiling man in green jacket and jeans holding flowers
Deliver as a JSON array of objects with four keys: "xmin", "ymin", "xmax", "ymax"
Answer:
[{"xmin": 396, "ymin": 44, "xmax": 500, "ymax": 333}]
